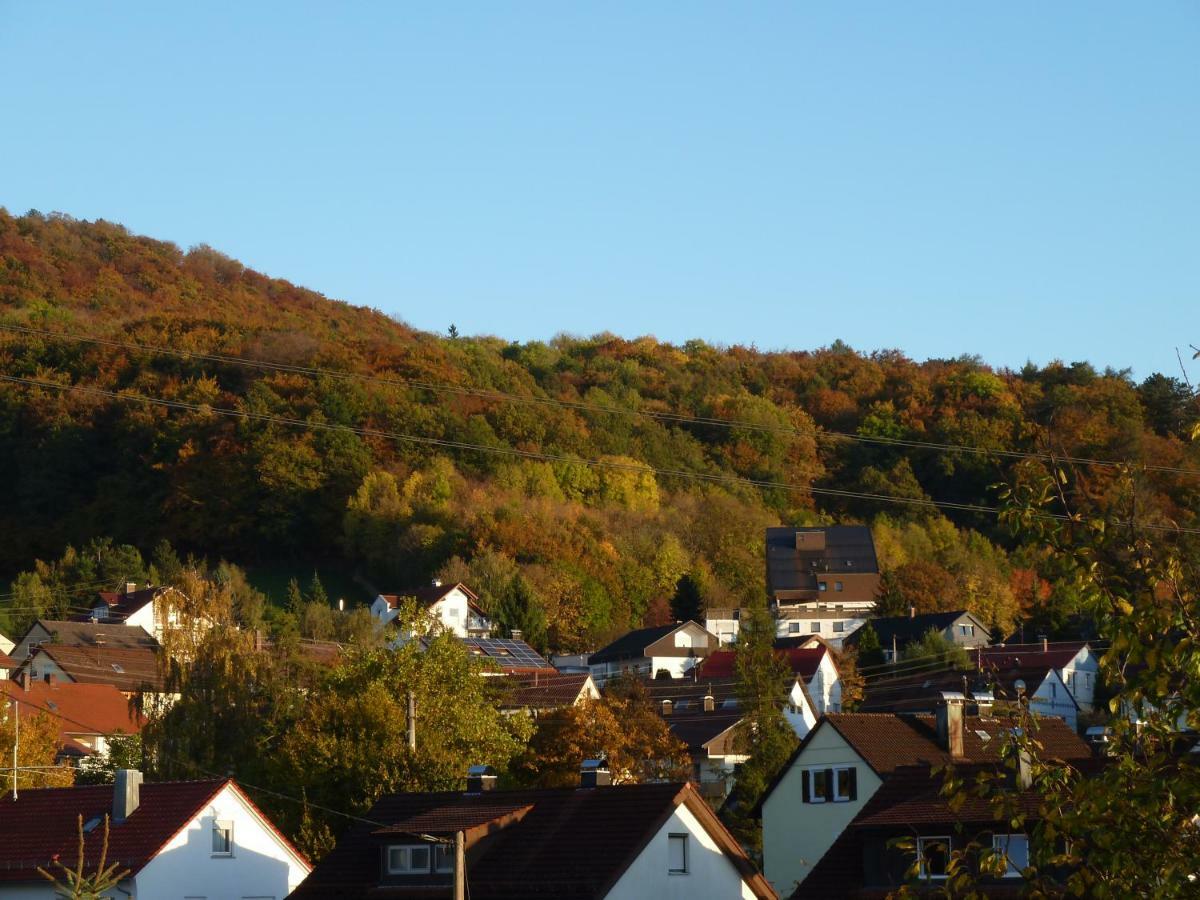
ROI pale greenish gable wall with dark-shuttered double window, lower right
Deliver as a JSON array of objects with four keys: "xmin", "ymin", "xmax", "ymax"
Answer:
[{"xmin": 762, "ymin": 722, "xmax": 883, "ymax": 896}]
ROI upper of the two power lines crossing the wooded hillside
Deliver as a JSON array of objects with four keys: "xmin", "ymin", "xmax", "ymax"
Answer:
[{"xmin": 0, "ymin": 323, "xmax": 1200, "ymax": 475}]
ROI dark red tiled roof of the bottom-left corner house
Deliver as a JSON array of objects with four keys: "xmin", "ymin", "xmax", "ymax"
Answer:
[{"xmin": 0, "ymin": 780, "xmax": 223, "ymax": 882}]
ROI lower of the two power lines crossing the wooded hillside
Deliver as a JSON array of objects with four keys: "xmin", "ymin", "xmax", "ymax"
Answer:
[{"xmin": 0, "ymin": 374, "xmax": 1200, "ymax": 534}]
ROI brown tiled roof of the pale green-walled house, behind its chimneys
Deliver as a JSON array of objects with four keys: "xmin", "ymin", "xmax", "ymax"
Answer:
[{"xmin": 758, "ymin": 713, "xmax": 1092, "ymax": 809}]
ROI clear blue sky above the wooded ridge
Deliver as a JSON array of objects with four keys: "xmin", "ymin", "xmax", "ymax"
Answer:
[{"xmin": 0, "ymin": 0, "xmax": 1200, "ymax": 377}]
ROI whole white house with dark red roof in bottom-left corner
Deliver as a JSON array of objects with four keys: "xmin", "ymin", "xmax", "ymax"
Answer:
[{"xmin": 0, "ymin": 769, "xmax": 311, "ymax": 900}]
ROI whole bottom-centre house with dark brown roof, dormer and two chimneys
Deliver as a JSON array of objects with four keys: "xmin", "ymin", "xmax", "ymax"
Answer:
[{"xmin": 293, "ymin": 766, "xmax": 775, "ymax": 900}]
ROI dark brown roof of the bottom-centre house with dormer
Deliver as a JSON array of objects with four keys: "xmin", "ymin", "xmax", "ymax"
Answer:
[{"xmin": 292, "ymin": 784, "xmax": 775, "ymax": 900}]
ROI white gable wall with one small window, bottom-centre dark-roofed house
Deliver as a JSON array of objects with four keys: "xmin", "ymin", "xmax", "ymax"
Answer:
[{"xmin": 605, "ymin": 805, "xmax": 754, "ymax": 900}]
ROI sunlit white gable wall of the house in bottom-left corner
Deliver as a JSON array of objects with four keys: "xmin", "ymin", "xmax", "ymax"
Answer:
[{"xmin": 132, "ymin": 785, "xmax": 308, "ymax": 900}]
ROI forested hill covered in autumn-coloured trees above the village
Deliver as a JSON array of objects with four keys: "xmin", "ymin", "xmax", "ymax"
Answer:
[{"xmin": 0, "ymin": 211, "xmax": 1200, "ymax": 648}]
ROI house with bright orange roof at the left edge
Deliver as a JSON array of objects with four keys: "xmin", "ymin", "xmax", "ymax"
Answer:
[{"xmin": 0, "ymin": 679, "xmax": 143, "ymax": 758}]
